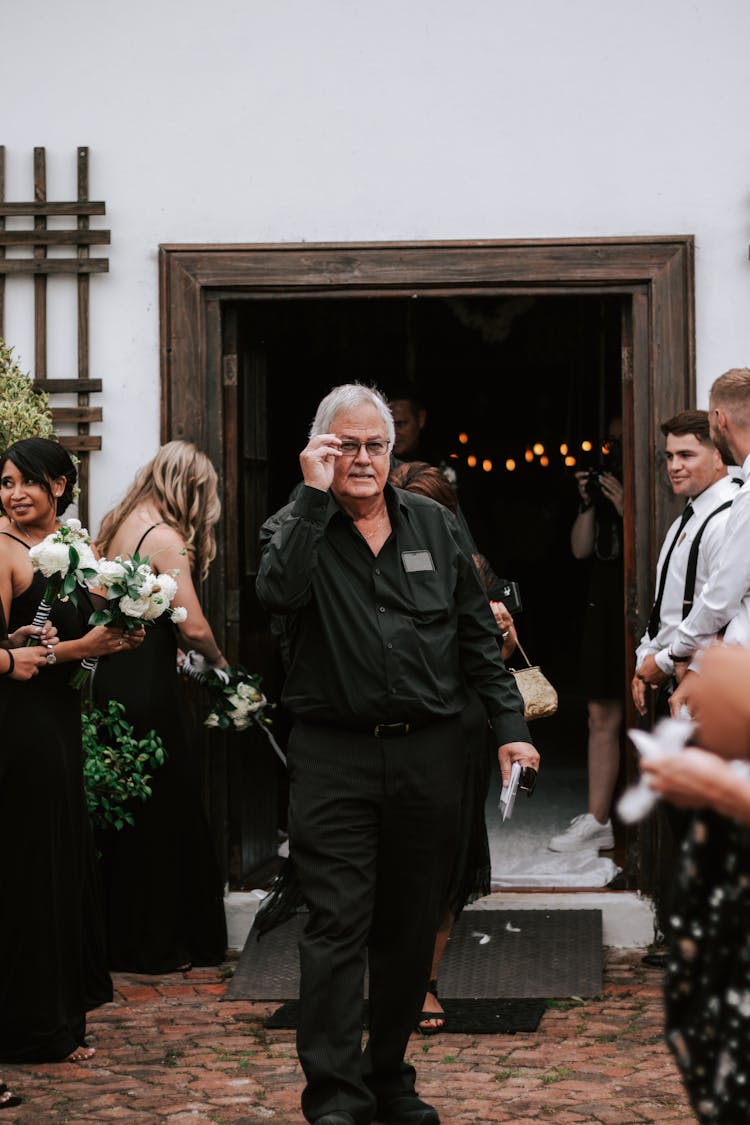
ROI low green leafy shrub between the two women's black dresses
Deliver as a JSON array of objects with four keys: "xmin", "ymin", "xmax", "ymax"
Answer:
[{"xmin": 81, "ymin": 700, "xmax": 166, "ymax": 829}]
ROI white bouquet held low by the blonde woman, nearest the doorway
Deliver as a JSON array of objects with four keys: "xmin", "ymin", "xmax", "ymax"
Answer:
[{"xmin": 180, "ymin": 651, "xmax": 287, "ymax": 765}]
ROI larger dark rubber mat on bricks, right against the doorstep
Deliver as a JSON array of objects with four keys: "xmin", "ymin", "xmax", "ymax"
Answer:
[{"xmin": 227, "ymin": 910, "xmax": 602, "ymax": 1000}]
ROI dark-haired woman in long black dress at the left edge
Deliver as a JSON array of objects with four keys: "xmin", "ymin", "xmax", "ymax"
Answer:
[{"xmin": 0, "ymin": 438, "xmax": 137, "ymax": 1063}]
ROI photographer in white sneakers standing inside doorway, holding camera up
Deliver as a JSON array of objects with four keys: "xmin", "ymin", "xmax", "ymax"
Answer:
[{"xmin": 548, "ymin": 416, "xmax": 625, "ymax": 852}]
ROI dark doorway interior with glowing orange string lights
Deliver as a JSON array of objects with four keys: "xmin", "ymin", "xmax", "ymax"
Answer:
[{"xmin": 235, "ymin": 295, "xmax": 626, "ymax": 865}]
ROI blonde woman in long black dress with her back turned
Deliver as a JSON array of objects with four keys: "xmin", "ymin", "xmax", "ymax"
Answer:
[{"xmin": 93, "ymin": 441, "xmax": 226, "ymax": 973}]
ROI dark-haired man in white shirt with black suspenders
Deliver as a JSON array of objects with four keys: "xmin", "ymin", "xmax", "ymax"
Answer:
[{"xmin": 631, "ymin": 411, "xmax": 738, "ymax": 714}]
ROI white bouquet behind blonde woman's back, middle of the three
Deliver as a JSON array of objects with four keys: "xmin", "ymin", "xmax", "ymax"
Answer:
[{"xmin": 71, "ymin": 554, "xmax": 188, "ymax": 687}]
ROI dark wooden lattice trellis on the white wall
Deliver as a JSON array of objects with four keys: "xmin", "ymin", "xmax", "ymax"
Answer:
[{"xmin": 0, "ymin": 145, "xmax": 110, "ymax": 527}]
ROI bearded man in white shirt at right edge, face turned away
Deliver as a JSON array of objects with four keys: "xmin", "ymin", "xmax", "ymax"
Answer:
[{"xmin": 669, "ymin": 368, "xmax": 750, "ymax": 714}]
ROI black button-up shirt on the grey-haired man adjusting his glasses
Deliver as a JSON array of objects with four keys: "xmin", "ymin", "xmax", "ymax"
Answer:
[{"xmin": 256, "ymin": 485, "xmax": 531, "ymax": 746}]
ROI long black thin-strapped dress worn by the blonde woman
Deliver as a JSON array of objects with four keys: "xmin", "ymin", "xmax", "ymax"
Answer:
[{"xmin": 93, "ymin": 524, "xmax": 226, "ymax": 973}]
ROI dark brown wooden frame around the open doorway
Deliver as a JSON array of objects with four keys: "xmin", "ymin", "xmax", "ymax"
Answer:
[{"xmin": 159, "ymin": 234, "xmax": 695, "ymax": 896}]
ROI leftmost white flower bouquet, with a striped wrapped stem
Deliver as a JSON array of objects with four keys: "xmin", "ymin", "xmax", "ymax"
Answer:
[{"xmin": 27, "ymin": 520, "xmax": 99, "ymax": 645}]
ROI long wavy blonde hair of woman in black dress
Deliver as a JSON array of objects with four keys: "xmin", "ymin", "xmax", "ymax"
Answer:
[{"xmin": 97, "ymin": 441, "xmax": 222, "ymax": 582}]
